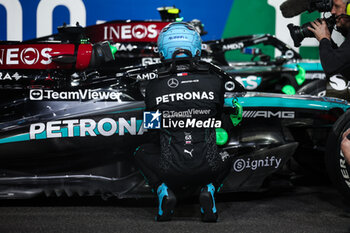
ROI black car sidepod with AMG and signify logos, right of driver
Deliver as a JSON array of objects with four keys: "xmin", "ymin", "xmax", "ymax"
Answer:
[{"xmin": 217, "ymin": 93, "xmax": 349, "ymax": 192}]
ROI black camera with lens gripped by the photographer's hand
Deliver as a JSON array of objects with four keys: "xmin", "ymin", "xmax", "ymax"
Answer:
[{"xmin": 287, "ymin": 16, "xmax": 336, "ymax": 47}]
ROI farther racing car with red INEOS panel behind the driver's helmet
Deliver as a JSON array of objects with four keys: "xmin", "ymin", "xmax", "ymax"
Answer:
[{"xmin": 18, "ymin": 7, "xmax": 326, "ymax": 95}]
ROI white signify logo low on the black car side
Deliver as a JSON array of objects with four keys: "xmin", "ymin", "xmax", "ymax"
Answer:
[{"xmin": 233, "ymin": 156, "xmax": 282, "ymax": 172}]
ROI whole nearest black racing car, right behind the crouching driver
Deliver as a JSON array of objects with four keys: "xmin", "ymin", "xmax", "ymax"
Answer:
[{"xmin": 0, "ymin": 6, "xmax": 350, "ymax": 198}]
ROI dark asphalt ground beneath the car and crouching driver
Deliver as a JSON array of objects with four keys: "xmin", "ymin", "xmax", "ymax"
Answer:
[{"xmin": 0, "ymin": 176, "xmax": 350, "ymax": 233}]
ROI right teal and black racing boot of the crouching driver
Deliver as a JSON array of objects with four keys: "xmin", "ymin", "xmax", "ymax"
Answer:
[{"xmin": 199, "ymin": 183, "xmax": 218, "ymax": 222}]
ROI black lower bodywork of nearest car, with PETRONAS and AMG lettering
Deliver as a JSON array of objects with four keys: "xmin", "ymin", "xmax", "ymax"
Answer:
[{"xmin": 0, "ymin": 66, "xmax": 349, "ymax": 198}]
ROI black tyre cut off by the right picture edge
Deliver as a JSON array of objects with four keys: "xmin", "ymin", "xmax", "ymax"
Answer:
[{"xmin": 325, "ymin": 111, "xmax": 350, "ymax": 200}]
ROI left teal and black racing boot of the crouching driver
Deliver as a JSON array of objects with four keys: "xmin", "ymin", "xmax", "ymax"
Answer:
[{"xmin": 156, "ymin": 183, "xmax": 176, "ymax": 221}]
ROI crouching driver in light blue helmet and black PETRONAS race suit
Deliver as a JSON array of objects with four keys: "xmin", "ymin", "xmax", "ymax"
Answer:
[{"xmin": 135, "ymin": 22, "xmax": 230, "ymax": 222}]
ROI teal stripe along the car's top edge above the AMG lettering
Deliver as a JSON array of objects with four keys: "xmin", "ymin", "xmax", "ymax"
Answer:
[{"xmin": 225, "ymin": 96, "xmax": 350, "ymax": 111}]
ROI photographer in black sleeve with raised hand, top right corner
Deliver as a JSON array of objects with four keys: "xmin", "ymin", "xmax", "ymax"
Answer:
[{"xmin": 308, "ymin": 0, "xmax": 350, "ymax": 79}]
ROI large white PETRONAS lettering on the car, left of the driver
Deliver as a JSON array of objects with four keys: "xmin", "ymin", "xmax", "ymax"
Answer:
[{"xmin": 29, "ymin": 117, "xmax": 146, "ymax": 140}]
